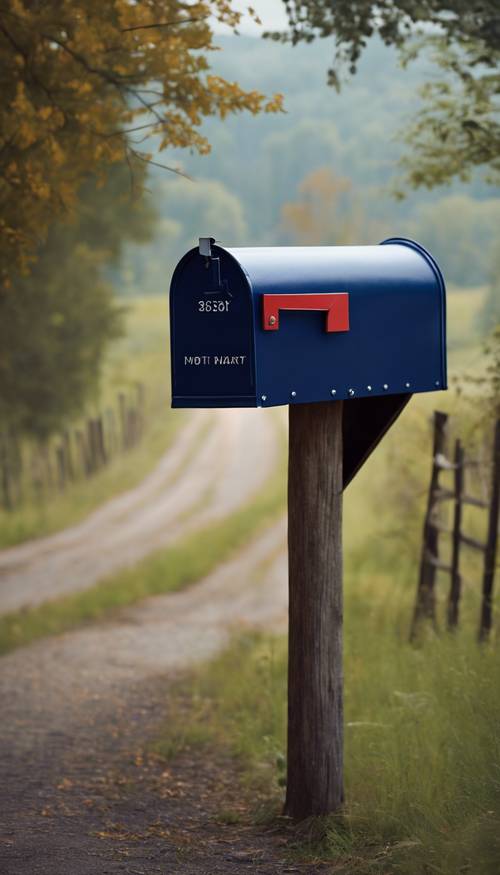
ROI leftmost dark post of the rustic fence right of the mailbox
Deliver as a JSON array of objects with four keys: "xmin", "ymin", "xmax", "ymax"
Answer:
[{"xmin": 410, "ymin": 410, "xmax": 448, "ymax": 640}]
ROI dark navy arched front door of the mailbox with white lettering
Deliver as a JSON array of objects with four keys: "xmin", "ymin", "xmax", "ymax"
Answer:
[{"xmin": 170, "ymin": 249, "xmax": 256, "ymax": 407}]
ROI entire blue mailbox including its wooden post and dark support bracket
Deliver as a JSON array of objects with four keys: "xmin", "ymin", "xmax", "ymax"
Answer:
[{"xmin": 170, "ymin": 237, "xmax": 446, "ymax": 819}]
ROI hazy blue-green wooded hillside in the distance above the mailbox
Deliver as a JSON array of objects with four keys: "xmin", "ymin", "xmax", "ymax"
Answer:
[{"xmin": 118, "ymin": 36, "xmax": 500, "ymax": 290}]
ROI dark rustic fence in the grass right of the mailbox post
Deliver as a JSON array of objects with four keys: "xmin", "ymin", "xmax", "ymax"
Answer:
[{"xmin": 410, "ymin": 411, "xmax": 500, "ymax": 641}]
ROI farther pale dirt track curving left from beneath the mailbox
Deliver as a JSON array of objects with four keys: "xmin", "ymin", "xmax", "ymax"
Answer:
[{"xmin": 0, "ymin": 409, "xmax": 278, "ymax": 614}]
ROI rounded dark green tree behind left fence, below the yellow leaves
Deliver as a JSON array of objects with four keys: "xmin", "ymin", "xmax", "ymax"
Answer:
[{"xmin": 0, "ymin": 250, "xmax": 120, "ymax": 441}]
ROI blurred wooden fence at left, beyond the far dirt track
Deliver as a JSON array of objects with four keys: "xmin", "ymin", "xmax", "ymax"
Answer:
[{"xmin": 0, "ymin": 383, "xmax": 146, "ymax": 510}]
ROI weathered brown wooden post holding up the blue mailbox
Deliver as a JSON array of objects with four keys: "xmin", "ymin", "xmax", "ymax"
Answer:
[{"xmin": 285, "ymin": 401, "xmax": 344, "ymax": 820}]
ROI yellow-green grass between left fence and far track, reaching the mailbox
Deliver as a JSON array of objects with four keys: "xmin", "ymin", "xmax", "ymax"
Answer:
[{"xmin": 0, "ymin": 295, "xmax": 178, "ymax": 549}]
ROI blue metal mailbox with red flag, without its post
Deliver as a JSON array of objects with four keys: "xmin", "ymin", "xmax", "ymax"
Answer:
[{"xmin": 170, "ymin": 238, "xmax": 447, "ymax": 407}]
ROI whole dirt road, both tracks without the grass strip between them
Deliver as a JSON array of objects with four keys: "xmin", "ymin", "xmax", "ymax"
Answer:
[{"xmin": 0, "ymin": 411, "xmax": 319, "ymax": 875}]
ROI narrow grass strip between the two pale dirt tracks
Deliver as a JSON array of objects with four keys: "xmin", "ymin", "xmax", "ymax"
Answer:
[{"xmin": 0, "ymin": 444, "xmax": 286, "ymax": 654}]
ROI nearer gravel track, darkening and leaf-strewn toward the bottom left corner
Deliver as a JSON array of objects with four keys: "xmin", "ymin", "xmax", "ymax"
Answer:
[{"xmin": 0, "ymin": 521, "xmax": 290, "ymax": 875}]
